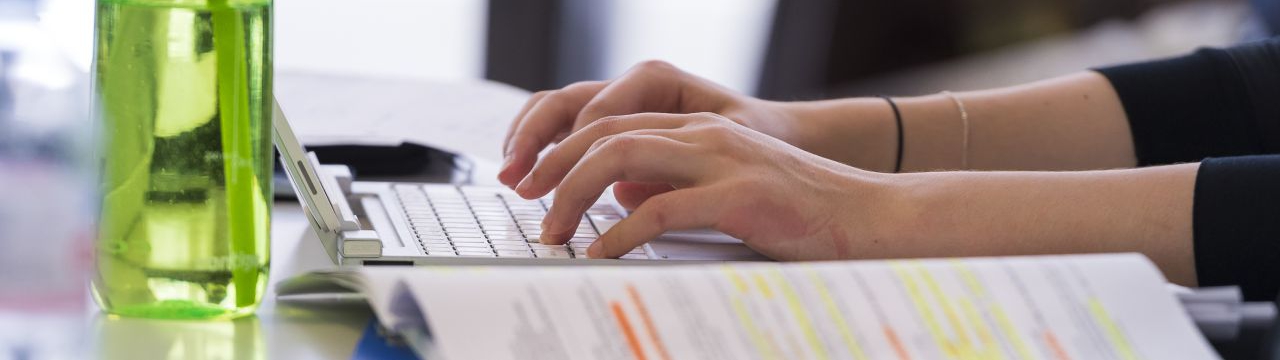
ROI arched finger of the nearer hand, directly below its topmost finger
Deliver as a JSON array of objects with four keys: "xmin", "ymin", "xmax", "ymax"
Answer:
[{"xmin": 541, "ymin": 135, "xmax": 701, "ymax": 243}]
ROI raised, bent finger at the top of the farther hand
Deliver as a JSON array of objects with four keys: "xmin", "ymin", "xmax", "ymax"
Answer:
[{"xmin": 572, "ymin": 60, "xmax": 686, "ymax": 131}]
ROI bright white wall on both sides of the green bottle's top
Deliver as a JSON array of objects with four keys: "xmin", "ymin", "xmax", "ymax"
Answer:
[{"xmin": 41, "ymin": 0, "xmax": 489, "ymax": 81}]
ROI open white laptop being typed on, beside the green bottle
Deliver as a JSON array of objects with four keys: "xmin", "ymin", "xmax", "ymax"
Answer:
[{"xmin": 273, "ymin": 99, "xmax": 767, "ymax": 265}]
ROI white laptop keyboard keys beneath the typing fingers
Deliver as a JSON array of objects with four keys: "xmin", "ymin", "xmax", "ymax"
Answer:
[{"xmin": 394, "ymin": 184, "xmax": 649, "ymax": 259}]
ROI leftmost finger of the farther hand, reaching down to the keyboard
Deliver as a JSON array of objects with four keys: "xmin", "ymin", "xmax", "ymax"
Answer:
[{"xmin": 498, "ymin": 82, "xmax": 607, "ymax": 186}]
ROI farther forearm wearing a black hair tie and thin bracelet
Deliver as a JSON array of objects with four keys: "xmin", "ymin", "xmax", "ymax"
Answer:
[{"xmin": 787, "ymin": 72, "xmax": 1137, "ymax": 172}]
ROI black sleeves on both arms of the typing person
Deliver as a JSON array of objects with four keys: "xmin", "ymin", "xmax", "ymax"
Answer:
[{"xmin": 1098, "ymin": 37, "xmax": 1280, "ymax": 300}]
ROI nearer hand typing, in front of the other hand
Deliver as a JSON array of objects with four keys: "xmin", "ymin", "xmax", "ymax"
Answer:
[{"xmin": 506, "ymin": 113, "xmax": 890, "ymax": 260}]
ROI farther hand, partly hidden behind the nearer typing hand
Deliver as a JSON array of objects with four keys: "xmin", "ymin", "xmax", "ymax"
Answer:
[{"xmin": 498, "ymin": 61, "xmax": 794, "ymax": 188}]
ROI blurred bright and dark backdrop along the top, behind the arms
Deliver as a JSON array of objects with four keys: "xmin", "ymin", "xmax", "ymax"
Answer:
[{"xmin": 12, "ymin": 0, "xmax": 1280, "ymax": 99}]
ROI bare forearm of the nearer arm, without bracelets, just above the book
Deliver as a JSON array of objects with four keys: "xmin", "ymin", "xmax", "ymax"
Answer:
[{"xmin": 867, "ymin": 164, "xmax": 1199, "ymax": 286}]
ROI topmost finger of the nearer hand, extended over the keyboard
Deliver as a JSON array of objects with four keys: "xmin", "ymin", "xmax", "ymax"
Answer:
[{"xmin": 516, "ymin": 113, "xmax": 690, "ymax": 199}]
